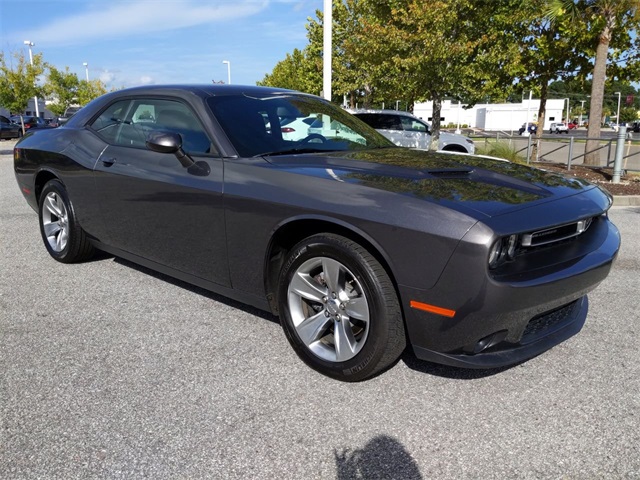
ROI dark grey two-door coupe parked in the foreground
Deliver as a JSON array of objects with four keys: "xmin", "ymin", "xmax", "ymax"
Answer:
[{"xmin": 14, "ymin": 85, "xmax": 620, "ymax": 381}]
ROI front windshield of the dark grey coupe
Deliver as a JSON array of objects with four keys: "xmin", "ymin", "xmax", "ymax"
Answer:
[{"xmin": 207, "ymin": 93, "xmax": 393, "ymax": 157}]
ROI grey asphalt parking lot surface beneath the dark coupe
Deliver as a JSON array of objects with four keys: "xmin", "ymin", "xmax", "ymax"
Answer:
[{"xmin": 0, "ymin": 141, "xmax": 640, "ymax": 479}]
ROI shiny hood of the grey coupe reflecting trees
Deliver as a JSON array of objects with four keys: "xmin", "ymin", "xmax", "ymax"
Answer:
[{"xmin": 265, "ymin": 147, "xmax": 610, "ymax": 216}]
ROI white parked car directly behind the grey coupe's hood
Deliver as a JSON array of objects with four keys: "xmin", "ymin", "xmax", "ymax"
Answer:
[{"xmin": 349, "ymin": 110, "xmax": 476, "ymax": 153}]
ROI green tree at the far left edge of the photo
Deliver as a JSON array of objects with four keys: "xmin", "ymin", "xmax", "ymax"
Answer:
[{"xmin": 0, "ymin": 52, "xmax": 44, "ymax": 113}]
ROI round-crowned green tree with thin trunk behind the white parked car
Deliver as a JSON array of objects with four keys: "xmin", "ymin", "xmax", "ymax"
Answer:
[{"xmin": 350, "ymin": 0, "xmax": 522, "ymax": 149}]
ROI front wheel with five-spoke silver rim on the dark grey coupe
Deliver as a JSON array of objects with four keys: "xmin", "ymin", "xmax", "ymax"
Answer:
[{"xmin": 278, "ymin": 234, "xmax": 406, "ymax": 382}]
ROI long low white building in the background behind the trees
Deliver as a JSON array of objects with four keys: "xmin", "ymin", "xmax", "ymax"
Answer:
[{"xmin": 413, "ymin": 99, "xmax": 567, "ymax": 132}]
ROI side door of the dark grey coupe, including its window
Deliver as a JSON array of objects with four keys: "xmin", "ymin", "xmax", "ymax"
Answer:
[{"xmin": 91, "ymin": 98, "xmax": 230, "ymax": 286}]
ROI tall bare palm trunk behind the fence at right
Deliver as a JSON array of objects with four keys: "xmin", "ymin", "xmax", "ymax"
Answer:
[{"xmin": 584, "ymin": 25, "xmax": 611, "ymax": 165}]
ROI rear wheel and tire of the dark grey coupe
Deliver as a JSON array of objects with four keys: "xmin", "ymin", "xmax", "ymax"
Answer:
[{"xmin": 38, "ymin": 180, "xmax": 95, "ymax": 263}]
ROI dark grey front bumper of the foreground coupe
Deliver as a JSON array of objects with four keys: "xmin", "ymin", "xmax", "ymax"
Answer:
[{"xmin": 399, "ymin": 216, "xmax": 620, "ymax": 368}]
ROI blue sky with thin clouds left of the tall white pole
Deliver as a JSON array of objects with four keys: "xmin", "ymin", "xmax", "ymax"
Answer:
[{"xmin": 0, "ymin": 0, "xmax": 323, "ymax": 89}]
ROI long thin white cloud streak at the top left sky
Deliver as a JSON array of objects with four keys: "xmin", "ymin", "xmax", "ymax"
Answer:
[{"xmin": 21, "ymin": 0, "xmax": 269, "ymax": 46}]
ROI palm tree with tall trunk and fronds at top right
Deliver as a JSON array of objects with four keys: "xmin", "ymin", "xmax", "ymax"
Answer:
[{"xmin": 546, "ymin": 0, "xmax": 640, "ymax": 165}]
